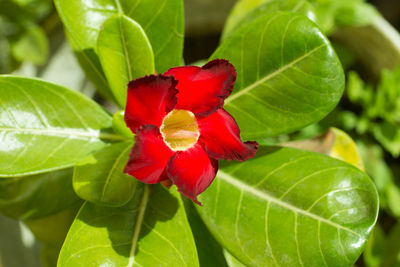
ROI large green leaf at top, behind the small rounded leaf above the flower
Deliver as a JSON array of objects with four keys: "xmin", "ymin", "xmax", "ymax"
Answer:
[{"xmin": 55, "ymin": 0, "xmax": 184, "ymax": 96}]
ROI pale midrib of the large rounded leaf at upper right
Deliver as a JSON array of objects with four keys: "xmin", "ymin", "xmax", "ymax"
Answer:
[{"xmin": 225, "ymin": 43, "xmax": 327, "ymax": 104}]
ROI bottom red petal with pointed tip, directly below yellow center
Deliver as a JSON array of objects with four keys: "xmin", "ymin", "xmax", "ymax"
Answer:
[{"xmin": 167, "ymin": 143, "xmax": 218, "ymax": 204}]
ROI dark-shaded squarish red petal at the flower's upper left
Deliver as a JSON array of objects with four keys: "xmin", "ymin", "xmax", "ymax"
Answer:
[{"xmin": 125, "ymin": 75, "xmax": 178, "ymax": 133}]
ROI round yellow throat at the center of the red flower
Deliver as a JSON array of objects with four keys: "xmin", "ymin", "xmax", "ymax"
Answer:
[{"xmin": 160, "ymin": 109, "xmax": 200, "ymax": 151}]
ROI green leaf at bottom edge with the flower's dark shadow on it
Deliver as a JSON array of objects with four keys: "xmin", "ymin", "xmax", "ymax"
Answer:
[{"xmin": 58, "ymin": 183, "xmax": 198, "ymax": 267}]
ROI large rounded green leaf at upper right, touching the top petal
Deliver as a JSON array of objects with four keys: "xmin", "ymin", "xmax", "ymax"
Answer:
[{"xmin": 211, "ymin": 12, "xmax": 344, "ymax": 139}]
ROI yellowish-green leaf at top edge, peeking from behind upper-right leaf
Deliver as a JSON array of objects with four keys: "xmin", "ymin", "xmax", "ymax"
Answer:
[{"xmin": 222, "ymin": 0, "xmax": 315, "ymax": 40}]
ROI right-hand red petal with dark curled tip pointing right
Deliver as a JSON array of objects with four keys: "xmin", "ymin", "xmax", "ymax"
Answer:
[{"xmin": 197, "ymin": 108, "xmax": 258, "ymax": 161}]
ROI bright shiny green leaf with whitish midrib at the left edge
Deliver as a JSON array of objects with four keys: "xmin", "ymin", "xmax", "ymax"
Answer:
[{"xmin": 0, "ymin": 76, "xmax": 124, "ymax": 177}]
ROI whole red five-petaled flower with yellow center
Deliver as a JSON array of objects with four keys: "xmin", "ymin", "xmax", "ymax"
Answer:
[{"xmin": 125, "ymin": 59, "xmax": 258, "ymax": 204}]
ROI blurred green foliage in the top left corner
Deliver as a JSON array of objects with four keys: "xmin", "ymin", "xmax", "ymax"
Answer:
[{"xmin": 0, "ymin": 0, "xmax": 53, "ymax": 74}]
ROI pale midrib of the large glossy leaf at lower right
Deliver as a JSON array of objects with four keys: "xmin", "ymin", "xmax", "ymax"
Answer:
[{"xmin": 218, "ymin": 170, "xmax": 362, "ymax": 238}]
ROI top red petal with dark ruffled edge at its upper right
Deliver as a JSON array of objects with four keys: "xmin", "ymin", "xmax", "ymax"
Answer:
[{"xmin": 165, "ymin": 59, "xmax": 236, "ymax": 116}]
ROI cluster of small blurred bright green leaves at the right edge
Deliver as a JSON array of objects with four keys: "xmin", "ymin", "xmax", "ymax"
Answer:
[{"xmin": 343, "ymin": 67, "xmax": 400, "ymax": 158}]
